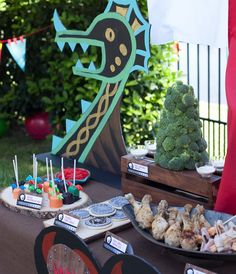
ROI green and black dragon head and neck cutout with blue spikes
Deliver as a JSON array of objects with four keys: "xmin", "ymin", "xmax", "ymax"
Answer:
[{"xmin": 51, "ymin": 0, "xmax": 150, "ymax": 173}]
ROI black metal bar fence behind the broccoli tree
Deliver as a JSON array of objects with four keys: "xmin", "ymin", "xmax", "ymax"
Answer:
[{"xmin": 177, "ymin": 43, "xmax": 228, "ymax": 157}]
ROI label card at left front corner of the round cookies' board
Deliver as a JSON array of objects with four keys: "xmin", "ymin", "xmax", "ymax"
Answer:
[{"xmin": 54, "ymin": 213, "xmax": 80, "ymax": 232}]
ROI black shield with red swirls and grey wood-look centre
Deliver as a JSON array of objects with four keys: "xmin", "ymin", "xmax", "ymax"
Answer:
[{"xmin": 34, "ymin": 226, "xmax": 101, "ymax": 274}]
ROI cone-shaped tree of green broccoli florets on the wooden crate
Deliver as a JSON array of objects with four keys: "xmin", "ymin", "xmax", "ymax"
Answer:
[{"xmin": 155, "ymin": 81, "xmax": 208, "ymax": 170}]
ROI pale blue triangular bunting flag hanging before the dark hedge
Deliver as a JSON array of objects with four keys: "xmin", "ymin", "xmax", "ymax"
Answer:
[{"xmin": 6, "ymin": 37, "xmax": 26, "ymax": 71}]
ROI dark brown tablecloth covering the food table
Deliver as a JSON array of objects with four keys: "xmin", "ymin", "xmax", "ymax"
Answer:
[{"xmin": 0, "ymin": 181, "xmax": 236, "ymax": 274}]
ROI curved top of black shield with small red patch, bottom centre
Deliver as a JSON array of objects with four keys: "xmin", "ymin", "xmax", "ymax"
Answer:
[{"xmin": 101, "ymin": 254, "xmax": 161, "ymax": 274}]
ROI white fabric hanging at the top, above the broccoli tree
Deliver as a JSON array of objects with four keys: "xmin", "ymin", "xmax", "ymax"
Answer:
[{"xmin": 147, "ymin": 0, "xmax": 229, "ymax": 47}]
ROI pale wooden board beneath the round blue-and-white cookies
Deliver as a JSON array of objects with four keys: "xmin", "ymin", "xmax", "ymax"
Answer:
[{"xmin": 43, "ymin": 201, "xmax": 131, "ymax": 242}]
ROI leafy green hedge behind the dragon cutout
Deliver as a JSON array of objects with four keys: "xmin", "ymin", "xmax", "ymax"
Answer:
[{"xmin": 0, "ymin": 0, "xmax": 179, "ymax": 144}]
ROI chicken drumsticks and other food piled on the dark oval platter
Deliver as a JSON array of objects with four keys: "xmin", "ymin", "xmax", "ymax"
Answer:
[{"xmin": 125, "ymin": 193, "xmax": 236, "ymax": 253}]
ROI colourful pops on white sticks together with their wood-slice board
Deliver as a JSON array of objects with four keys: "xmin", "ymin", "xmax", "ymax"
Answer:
[{"xmin": 1, "ymin": 154, "xmax": 89, "ymax": 218}]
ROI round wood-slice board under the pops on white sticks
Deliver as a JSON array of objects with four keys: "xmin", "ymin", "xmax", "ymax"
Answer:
[{"xmin": 0, "ymin": 187, "xmax": 92, "ymax": 219}]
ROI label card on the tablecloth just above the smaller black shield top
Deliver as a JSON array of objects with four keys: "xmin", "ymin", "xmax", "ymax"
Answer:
[{"xmin": 103, "ymin": 231, "xmax": 134, "ymax": 255}]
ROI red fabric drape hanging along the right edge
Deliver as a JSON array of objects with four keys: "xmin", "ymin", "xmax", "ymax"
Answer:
[{"xmin": 215, "ymin": 0, "xmax": 236, "ymax": 215}]
